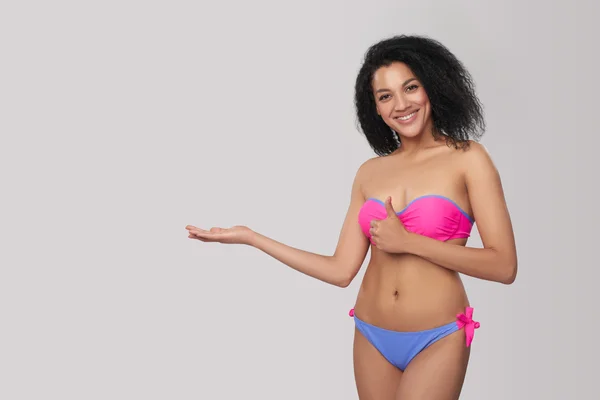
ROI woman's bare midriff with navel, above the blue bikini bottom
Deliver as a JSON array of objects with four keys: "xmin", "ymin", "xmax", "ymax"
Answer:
[{"xmin": 354, "ymin": 255, "xmax": 469, "ymax": 331}]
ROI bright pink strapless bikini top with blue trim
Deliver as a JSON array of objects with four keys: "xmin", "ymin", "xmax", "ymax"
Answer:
[{"xmin": 358, "ymin": 194, "xmax": 474, "ymax": 241}]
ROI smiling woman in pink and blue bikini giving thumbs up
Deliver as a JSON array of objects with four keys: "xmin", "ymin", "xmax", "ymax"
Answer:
[{"xmin": 186, "ymin": 36, "xmax": 517, "ymax": 400}]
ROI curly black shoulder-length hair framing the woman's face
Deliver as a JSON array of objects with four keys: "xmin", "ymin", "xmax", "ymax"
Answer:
[{"xmin": 354, "ymin": 35, "xmax": 485, "ymax": 156}]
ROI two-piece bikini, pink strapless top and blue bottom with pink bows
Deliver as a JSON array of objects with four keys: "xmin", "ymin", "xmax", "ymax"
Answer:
[{"xmin": 350, "ymin": 194, "xmax": 480, "ymax": 371}]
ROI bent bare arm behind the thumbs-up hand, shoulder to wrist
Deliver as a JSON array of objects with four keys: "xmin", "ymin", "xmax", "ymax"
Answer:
[{"xmin": 402, "ymin": 142, "xmax": 517, "ymax": 284}]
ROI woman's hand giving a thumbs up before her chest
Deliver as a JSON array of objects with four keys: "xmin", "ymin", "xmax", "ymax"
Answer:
[{"xmin": 369, "ymin": 196, "xmax": 410, "ymax": 253}]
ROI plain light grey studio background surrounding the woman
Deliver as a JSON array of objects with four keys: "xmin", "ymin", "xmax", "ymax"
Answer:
[{"xmin": 0, "ymin": 0, "xmax": 600, "ymax": 400}]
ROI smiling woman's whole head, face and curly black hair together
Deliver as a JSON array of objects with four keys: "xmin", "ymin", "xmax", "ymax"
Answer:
[{"xmin": 355, "ymin": 36, "xmax": 485, "ymax": 155}]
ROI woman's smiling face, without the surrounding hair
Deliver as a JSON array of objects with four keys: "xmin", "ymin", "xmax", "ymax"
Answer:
[{"xmin": 372, "ymin": 62, "xmax": 431, "ymax": 137}]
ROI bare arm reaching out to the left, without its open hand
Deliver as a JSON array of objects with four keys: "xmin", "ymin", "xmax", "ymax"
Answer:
[{"xmin": 248, "ymin": 167, "xmax": 369, "ymax": 287}]
